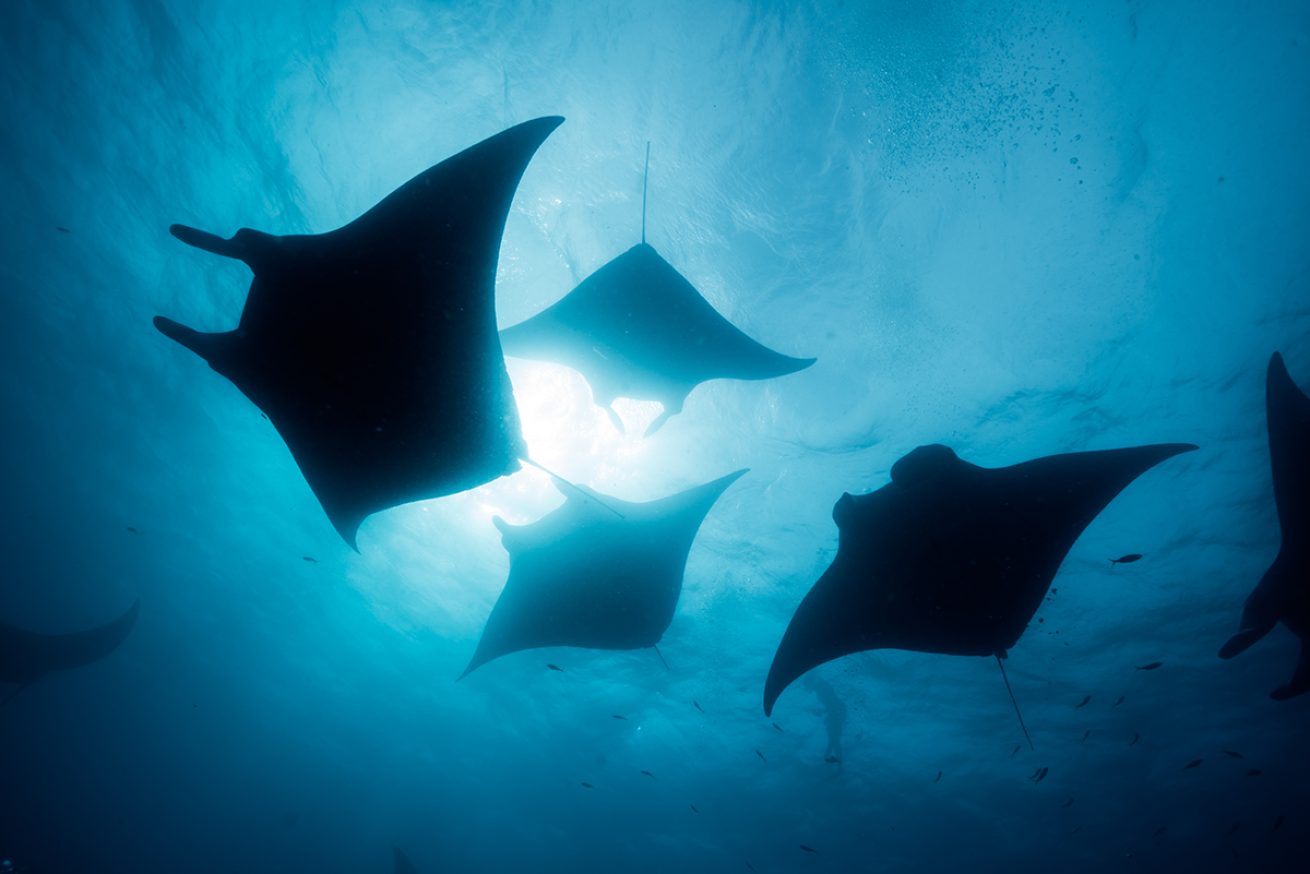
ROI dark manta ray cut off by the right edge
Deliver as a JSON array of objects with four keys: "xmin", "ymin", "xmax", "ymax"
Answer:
[{"xmin": 1220, "ymin": 352, "xmax": 1310, "ymax": 701}]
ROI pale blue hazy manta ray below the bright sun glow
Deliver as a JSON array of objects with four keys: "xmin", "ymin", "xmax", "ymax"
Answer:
[{"xmin": 460, "ymin": 470, "xmax": 745, "ymax": 680}]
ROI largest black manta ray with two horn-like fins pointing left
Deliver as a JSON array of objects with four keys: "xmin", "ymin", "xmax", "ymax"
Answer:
[{"xmin": 155, "ymin": 118, "xmax": 563, "ymax": 546}]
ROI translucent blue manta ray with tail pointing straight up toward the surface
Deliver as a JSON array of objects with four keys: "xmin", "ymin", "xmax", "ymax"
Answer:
[{"xmin": 500, "ymin": 242, "xmax": 816, "ymax": 436}]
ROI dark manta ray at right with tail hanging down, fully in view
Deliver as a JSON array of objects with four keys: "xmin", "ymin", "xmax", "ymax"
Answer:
[{"xmin": 764, "ymin": 443, "xmax": 1196, "ymax": 715}]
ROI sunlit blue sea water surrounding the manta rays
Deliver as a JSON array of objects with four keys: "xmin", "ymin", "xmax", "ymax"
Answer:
[{"xmin": 0, "ymin": 0, "xmax": 1310, "ymax": 874}]
